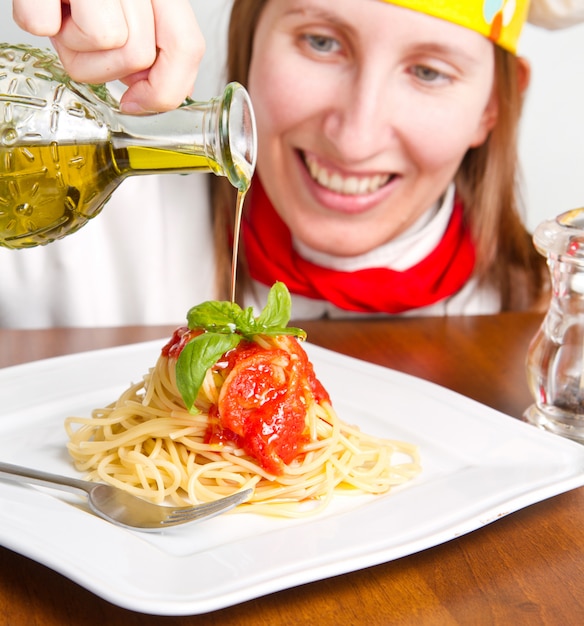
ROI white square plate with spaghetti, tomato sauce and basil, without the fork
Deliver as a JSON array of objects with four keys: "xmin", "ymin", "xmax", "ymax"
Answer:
[{"xmin": 0, "ymin": 286, "xmax": 584, "ymax": 615}]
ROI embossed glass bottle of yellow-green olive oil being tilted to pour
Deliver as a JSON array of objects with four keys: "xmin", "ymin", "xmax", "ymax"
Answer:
[{"xmin": 0, "ymin": 44, "xmax": 257, "ymax": 248}]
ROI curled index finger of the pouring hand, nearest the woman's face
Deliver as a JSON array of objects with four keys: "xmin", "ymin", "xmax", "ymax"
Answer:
[{"xmin": 121, "ymin": 0, "xmax": 205, "ymax": 113}]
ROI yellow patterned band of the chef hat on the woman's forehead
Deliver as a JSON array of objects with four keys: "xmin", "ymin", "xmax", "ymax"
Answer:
[{"xmin": 382, "ymin": 0, "xmax": 529, "ymax": 53}]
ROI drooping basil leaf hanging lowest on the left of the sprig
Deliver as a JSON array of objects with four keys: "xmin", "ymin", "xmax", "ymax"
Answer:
[{"xmin": 176, "ymin": 332, "xmax": 241, "ymax": 412}]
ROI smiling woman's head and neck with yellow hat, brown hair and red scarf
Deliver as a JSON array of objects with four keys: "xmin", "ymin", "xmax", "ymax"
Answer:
[{"xmin": 212, "ymin": 0, "xmax": 547, "ymax": 318}]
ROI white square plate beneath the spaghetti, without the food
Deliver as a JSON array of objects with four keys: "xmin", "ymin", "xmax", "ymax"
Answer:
[{"xmin": 0, "ymin": 340, "xmax": 584, "ymax": 615}]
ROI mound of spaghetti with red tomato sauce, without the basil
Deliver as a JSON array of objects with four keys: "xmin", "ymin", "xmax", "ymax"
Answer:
[{"xmin": 66, "ymin": 286, "xmax": 420, "ymax": 517}]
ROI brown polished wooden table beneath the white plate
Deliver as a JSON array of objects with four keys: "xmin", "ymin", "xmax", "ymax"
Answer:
[{"xmin": 0, "ymin": 313, "xmax": 584, "ymax": 626}]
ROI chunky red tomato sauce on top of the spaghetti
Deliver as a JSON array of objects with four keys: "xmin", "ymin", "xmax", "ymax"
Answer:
[{"xmin": 163, "ymin": 329, "xmax": 329, "ymax": 475}]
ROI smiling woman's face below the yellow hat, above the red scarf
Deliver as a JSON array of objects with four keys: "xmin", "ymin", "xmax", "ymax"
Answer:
[{"xmin": 248, "ymin": 0, "xmax": 497, "ymax": 256}]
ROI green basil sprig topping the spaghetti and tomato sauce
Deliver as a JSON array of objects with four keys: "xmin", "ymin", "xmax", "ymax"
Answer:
[{"xmin": 176, "ymin": 282, "xmax": 306, "ymax": 413}]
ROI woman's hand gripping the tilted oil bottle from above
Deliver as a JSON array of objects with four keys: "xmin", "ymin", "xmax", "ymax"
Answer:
[{"xmin": 12, "ymin": 0, "xmax": 205, "ymax": 113}]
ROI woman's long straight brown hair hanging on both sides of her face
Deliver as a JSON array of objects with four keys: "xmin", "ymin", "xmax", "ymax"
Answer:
[{"xmin": 211, "ymin": 0, "xmax": 548, "ymax": 310}]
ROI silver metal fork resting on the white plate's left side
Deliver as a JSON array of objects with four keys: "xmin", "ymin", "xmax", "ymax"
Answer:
[{"xmin": 0, "ymin": 462, "xmax": 253, "ymax": 532}]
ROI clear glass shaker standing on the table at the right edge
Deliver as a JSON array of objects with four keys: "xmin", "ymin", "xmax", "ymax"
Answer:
[{"xmin": 524, "ymin": 208, "xmax": 584, "ymax": 442}]
